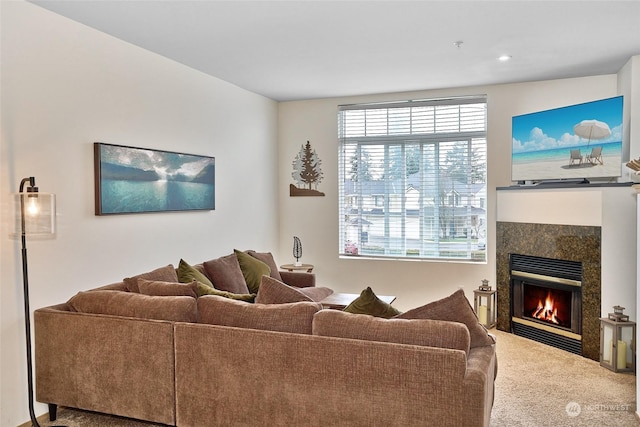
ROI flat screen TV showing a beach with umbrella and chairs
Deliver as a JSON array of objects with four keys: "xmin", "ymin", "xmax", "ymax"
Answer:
[{"xmin": 511, "ymin": 96, "xmax": 623, "ymax": 181}]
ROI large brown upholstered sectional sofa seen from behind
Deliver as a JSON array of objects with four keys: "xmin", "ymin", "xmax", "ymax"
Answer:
[{"xmin": 34, "ymin": 254, "xmax": 496, "ymax": 426}]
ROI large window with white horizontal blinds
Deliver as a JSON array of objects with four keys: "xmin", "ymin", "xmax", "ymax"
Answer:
[{"xmin": 338, "ymin": 97, "xmax": 487, "ymax": 262}]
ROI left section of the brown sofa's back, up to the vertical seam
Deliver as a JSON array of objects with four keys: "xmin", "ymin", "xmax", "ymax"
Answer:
[{"xmin": 34, "ymin": 306, "xmax": 175, "ymax": 425}]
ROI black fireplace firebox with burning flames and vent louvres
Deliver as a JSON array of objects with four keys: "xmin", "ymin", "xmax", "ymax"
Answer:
[{"xmin": 509, "ymin": 254, "xmax": 582, "ymax": 354}]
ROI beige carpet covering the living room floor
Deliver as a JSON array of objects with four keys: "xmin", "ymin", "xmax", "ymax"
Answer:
[{"xmin": 36, "ymin": 329, "xmax": 640, "ymax": 427}]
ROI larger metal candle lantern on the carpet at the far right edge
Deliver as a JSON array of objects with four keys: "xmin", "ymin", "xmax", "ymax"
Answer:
[{"xmin": 600, "ymin": 305, "xmax": 636, "ymax": 373}]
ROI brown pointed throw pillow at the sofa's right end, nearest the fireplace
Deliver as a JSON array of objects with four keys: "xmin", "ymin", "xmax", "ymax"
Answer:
[{"xmin": 396, "ymin": 289, "xmax": 495, "ymax": 348}]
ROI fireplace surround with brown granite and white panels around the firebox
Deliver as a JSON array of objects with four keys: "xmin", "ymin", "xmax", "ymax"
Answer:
[{"xmin": 496, "ymin": 186, "xmax": 637, "ymax": 360}]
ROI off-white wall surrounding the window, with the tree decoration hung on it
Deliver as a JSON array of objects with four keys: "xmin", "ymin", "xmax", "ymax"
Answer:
[{"xmin": 279, "ymin": 75, "xmax": 618, "ymax": 310}]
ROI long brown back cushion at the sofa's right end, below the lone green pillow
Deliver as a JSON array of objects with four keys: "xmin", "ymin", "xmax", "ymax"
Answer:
[{"xmin": 313, "ymin": 309, "xmax": 470, "ymax": 355}]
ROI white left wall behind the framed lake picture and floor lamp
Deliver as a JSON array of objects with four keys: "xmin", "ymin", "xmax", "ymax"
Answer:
[{"xmin": 0, "ymin": 1, "xmax": 278, "ymax": 426}]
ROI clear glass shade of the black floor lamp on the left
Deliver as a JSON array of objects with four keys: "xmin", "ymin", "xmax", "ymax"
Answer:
[{"xmin": 11, "ymin": 192, "xmax": 56, "ymax": 238}]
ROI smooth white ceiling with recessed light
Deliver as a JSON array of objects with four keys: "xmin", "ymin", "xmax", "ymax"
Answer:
[{"xmin": 31, "ymin": 0, "xmax": 640, "ymax": 101}]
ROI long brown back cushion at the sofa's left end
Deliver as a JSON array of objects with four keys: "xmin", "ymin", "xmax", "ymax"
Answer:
[{"xmin": 67, "ymin": 291, "xmax": 198, "ymax": 322}]
